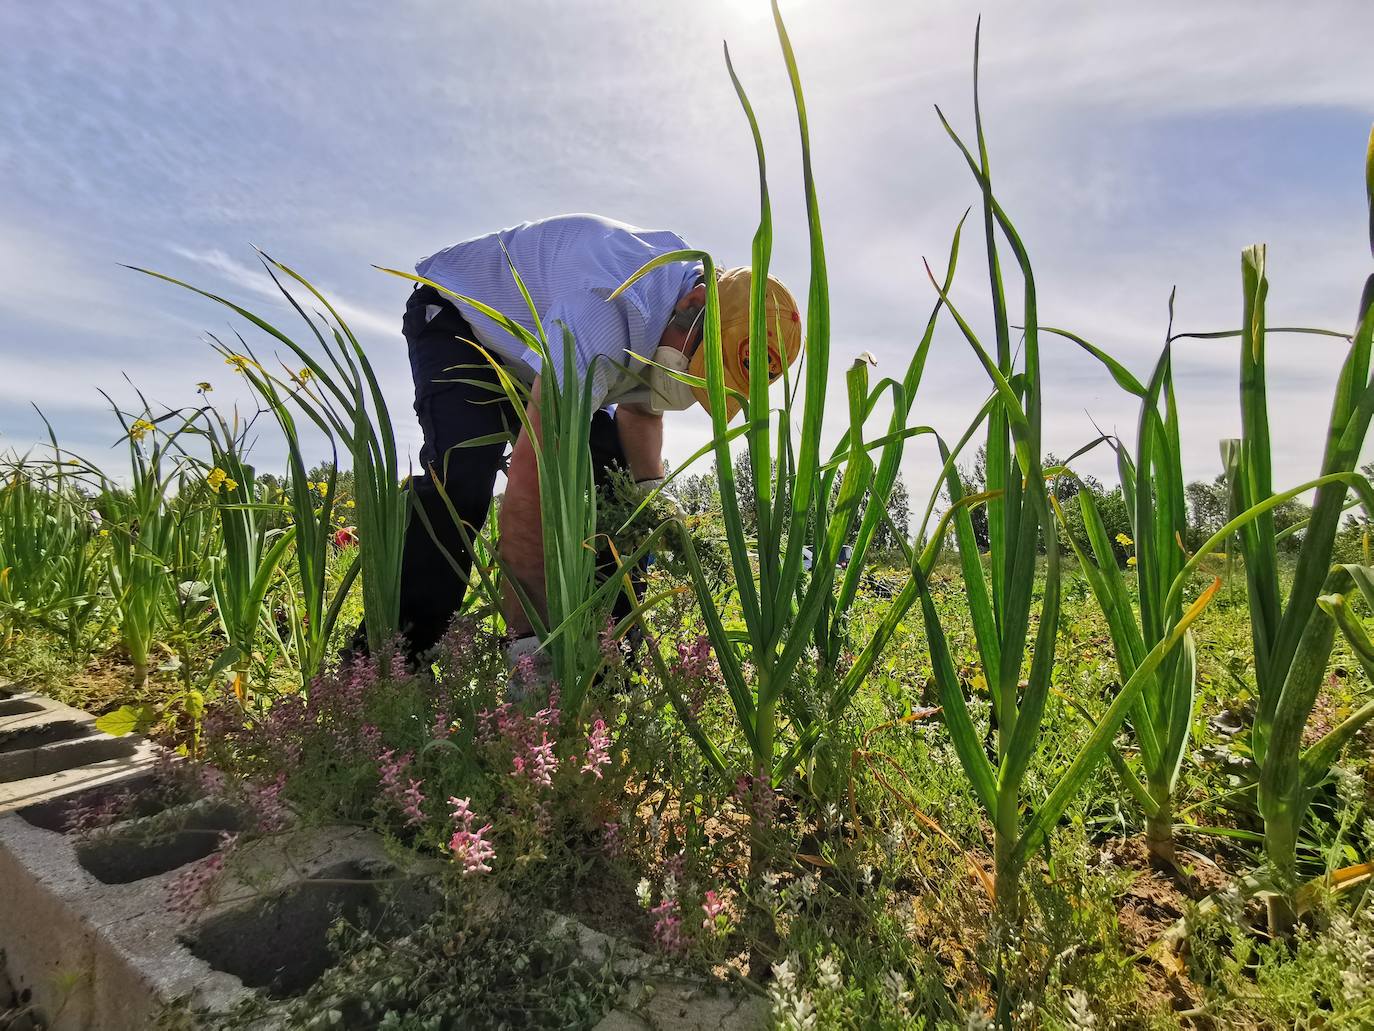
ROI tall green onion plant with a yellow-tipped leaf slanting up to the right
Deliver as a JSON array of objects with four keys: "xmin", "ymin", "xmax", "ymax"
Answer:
[{"xmin": 912, "ymin": 48, "xmax": 1216, "ymax": 945}]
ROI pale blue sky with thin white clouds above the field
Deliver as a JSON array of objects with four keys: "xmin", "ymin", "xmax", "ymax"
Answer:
[{"xmin": 0, "ymin": 0, "xmax": 1374, "ymax": 519}]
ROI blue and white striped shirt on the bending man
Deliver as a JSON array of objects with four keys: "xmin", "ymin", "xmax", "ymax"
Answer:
[{"xmin": 415, "ymin": 214, "xmax": 701, "ymax": 408}]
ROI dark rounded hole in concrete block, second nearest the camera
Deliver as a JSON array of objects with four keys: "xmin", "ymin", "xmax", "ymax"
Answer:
[{"xmin": 77, "ymin": 801, "xmax": 245, "ymax": 884}]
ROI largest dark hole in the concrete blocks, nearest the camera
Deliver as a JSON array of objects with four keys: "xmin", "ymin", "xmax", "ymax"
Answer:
[{"xmin": 183, "ymin": 862, "xmax": 438, "ymax": 998}]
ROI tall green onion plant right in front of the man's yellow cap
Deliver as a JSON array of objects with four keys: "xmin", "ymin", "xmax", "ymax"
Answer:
[{"xmin": 607, "ymin": 3, "xmax": 934, "ymax": 784}]
